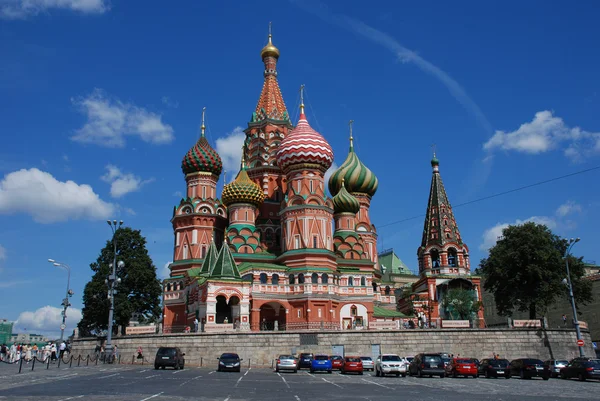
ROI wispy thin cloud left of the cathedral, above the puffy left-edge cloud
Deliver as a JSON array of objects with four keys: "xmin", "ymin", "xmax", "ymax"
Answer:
[{"xmin": 71, "ymin": 89, "xmax": 174, "ymax": 148}]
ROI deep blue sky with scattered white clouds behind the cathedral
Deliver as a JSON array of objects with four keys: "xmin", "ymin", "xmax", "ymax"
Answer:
[{"xmin": 0, "ymin": 0, "xmax": 600, "ymax": 333}]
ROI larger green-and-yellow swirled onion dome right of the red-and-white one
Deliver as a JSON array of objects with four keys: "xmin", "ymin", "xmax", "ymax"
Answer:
[{"xmin": 329, "ymin": 138, "xmax": 379, "ymax": 196}]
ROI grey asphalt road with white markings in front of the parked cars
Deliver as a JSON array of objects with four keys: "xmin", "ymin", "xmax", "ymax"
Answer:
[{"xmin": 0, "ymin": 364, "xmax": 600, "ymax": 401}]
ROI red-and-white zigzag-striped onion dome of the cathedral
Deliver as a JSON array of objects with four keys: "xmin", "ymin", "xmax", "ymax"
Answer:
[{"xmin": 277, "ymin": 112, "xmax": 333, "ymax": 172}]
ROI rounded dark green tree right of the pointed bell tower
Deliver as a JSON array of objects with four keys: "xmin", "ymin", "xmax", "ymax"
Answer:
[{"xmin": 480, "ymin": 222, "xmax": 592, "ymax": 319}]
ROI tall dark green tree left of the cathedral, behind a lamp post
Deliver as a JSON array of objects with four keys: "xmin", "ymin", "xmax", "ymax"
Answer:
[{"xmin": 77, "ymin": 228, "xmax": 162, "ymax": 335}]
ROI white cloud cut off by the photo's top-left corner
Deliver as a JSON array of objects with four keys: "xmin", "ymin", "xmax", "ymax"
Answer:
[{"xmin": 0, "ymin": 0, "xmax": 110, "ymax": 19}]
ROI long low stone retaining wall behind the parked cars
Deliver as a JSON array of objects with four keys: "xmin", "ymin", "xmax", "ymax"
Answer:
[{"xmin": 73, "ymin": 329, "xmax": 595, "ymax": 367}]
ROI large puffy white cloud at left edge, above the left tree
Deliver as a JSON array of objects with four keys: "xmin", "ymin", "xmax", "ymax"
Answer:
[{"xmin": 0, "ymin": 168, "xmax": 116, "ymax": 223}]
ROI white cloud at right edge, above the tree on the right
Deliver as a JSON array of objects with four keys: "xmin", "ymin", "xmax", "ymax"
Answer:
[{"xmin": 483, "ymin": 110, "xmax": 600, "ymax": 160}]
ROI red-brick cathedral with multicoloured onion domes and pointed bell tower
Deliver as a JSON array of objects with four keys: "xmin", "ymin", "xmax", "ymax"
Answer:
[{"xmin": 163, "ymin": 30, "xmax": 483, "ymax": 333}]
